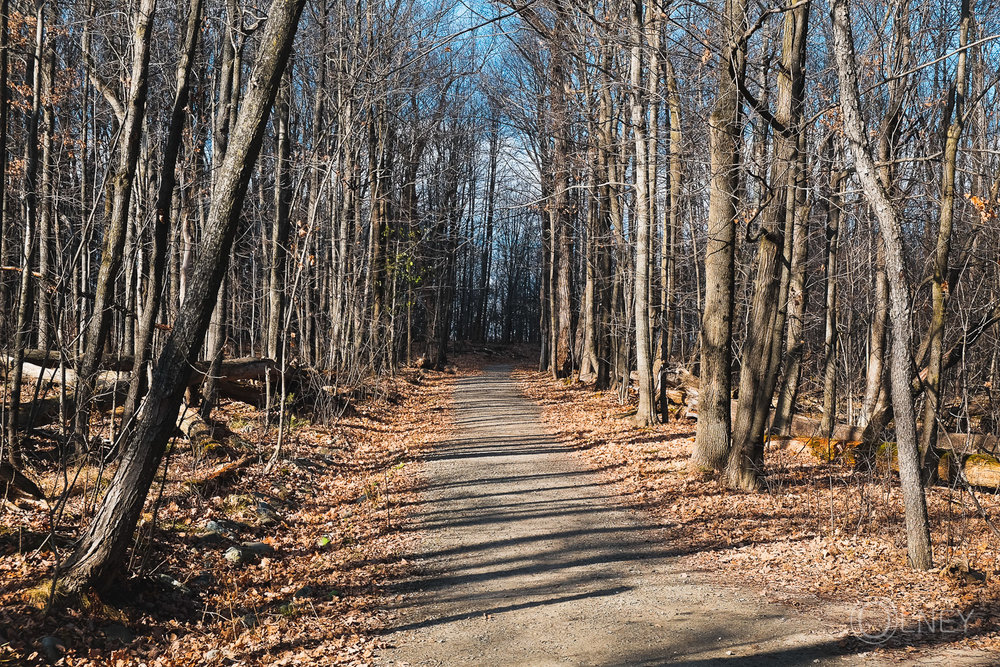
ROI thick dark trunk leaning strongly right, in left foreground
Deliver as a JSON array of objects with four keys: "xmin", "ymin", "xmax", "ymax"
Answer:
[{"xmin": 57, "ymin": 0, "xmax": 305, "ymax": 592}]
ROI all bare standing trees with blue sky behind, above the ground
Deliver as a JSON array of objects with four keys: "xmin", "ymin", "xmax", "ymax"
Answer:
[{"xmin": 0, "ymin": 0, "xmax": 1000, "ymax": 586}]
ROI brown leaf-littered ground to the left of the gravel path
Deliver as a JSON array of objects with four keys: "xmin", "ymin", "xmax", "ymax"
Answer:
[{"xmin": 0, "ymin": 369, "xmax": 455, "ymax": 667}]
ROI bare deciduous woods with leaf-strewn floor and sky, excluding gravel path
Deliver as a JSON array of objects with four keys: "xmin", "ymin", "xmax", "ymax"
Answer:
[{"xmin": 0, "ymin": 0, "xmax": 1000, "ymax": 664}]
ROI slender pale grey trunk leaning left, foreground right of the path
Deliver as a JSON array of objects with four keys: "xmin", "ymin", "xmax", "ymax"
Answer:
[{"xmin": 830, "ymin": 0, "xmax": 933, "ymax": 570}]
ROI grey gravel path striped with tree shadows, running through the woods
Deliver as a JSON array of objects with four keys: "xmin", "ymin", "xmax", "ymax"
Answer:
[{"xmin": 379, "ymin": 368, "xmax": 976, "ymax": 666}]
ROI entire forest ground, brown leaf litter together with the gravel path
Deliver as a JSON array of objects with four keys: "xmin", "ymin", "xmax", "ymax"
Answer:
[{"xmin": 0, "ymin": 358, "xmax": 1000, "ymax": 667}]
